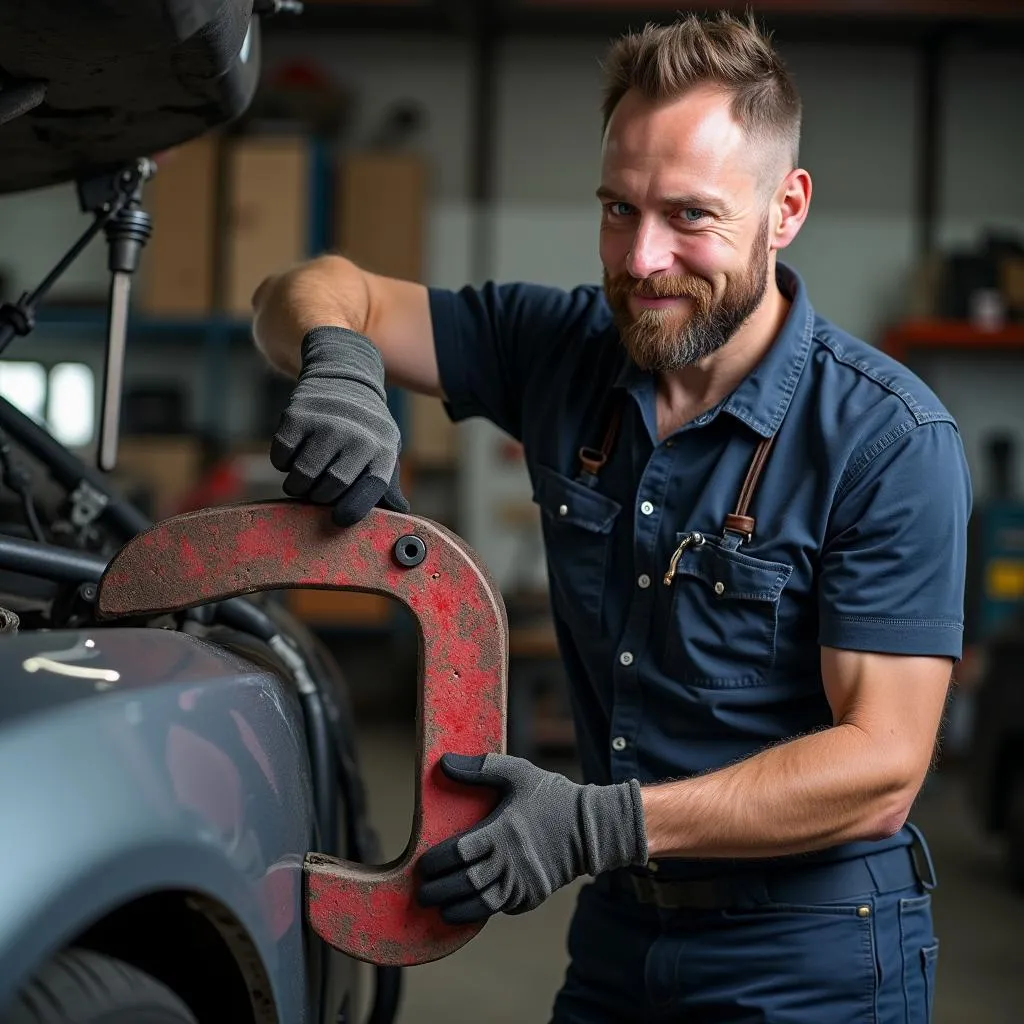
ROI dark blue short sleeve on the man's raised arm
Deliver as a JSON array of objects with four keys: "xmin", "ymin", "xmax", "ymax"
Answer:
[{"xmin": 428, "ymin": 283, "xmax": 607, "ymax": 439}]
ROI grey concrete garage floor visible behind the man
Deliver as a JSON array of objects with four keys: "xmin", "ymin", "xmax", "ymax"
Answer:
[{"xmin": 360, "ymin": 727, "xmax": 1024, "ymax": 1024}]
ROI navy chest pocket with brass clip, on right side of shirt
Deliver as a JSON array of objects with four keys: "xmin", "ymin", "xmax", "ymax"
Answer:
[{"xmin": 665, "ymin": 534, "xmax": 793, "ymax": 687}]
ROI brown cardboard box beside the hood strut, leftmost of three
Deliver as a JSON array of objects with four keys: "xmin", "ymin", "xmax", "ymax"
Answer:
[{"xmin": 136, "ymin": 135, "xmax": 219, "ymax": 316}]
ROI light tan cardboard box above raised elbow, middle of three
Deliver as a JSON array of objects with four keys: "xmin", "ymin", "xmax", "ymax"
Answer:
[{"xmin": 223, "ymin": 136, "xmax": 311, "ymax": 316}]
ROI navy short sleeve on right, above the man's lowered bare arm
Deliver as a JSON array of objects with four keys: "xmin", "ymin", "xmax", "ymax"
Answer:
[{"xmin": 819, "ymin": 421, "xmax": 972, "ymax": 658}]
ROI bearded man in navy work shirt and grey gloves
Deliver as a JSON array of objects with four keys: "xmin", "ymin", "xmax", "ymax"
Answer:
[{"xmin": 254, "ymin": 15, "xmax": 971, "ymax": 1024}]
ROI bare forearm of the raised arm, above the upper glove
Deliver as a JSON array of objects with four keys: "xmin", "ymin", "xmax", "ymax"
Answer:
[{"xmin": 253, "ymin": 256, "xmax": 370, "ymax": 377}]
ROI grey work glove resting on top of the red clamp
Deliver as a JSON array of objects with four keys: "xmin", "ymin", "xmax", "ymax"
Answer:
[{"xmin": 270, "ymin": 327, "xmax": 409, "ymax": 526}]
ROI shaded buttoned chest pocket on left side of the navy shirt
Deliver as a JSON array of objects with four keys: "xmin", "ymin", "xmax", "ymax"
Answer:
[{"xmin": 534, "ymin": 466, "xmax": 622, "ymax": 627}]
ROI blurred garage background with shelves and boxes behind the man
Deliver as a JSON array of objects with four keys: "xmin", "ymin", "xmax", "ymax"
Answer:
[{"xmin": 0, "ymin": 0, "xmax": 1024, "ymax": 1024}]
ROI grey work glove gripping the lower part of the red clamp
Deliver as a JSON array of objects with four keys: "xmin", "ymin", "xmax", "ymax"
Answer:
[{"xmin": 419, "ymin": 754, "xmax": 647, "ymax": 925}]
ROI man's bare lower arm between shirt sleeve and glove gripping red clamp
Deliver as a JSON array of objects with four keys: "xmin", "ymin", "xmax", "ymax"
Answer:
[{"xmin": 642, "ymin": 647, "xmax": 950, "ymax": 857}]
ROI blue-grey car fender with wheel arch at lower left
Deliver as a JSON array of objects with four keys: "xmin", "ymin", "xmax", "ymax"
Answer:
[{"xmin": 0, "ymin": 628, "xmax": 339, "ymax": 1024}]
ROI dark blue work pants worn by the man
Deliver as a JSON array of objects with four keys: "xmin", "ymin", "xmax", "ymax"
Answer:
[{"xmin": 552, "ymin": 843, "xmax": 938, "ymax": 1024}]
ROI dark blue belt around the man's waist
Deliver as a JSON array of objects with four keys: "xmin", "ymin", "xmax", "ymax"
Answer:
[{"xmin": 598, "ymin": 826, "xmax": 935, "ymax": 910}]
